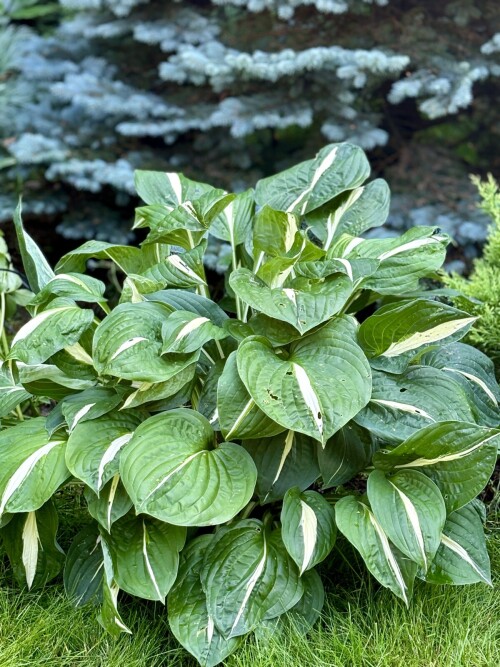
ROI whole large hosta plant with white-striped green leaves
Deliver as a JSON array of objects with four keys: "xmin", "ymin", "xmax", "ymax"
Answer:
[{"xmin": 0, "ymin": 144, "xmax": 500, "ymax": 665}]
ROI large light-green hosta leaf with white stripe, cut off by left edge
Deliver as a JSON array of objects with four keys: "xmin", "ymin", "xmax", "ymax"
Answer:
[{"xmin": 0, "ymin": 417, "xmax": 69, "ymax": 517}]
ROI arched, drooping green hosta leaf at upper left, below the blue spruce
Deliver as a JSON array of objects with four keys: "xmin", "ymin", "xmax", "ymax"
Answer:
[{"xmin": 56, "ymin": 241, "xmax": 143, "ymax": 274}]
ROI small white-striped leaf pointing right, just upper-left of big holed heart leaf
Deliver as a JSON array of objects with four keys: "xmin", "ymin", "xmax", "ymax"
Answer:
[{"xmin": 161, "ymin": 310, "xmax": 227, "ymax": 354}]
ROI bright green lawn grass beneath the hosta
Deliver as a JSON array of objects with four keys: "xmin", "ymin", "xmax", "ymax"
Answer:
[{"xmin": 0, "ymin": 521, "xmax": 500, "ymax": 667}]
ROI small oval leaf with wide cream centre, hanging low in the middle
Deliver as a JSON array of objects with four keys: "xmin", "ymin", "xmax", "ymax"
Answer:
[{"xmin": 281, "ymin": 487, "xmax": 337, "ymax": 576}]
